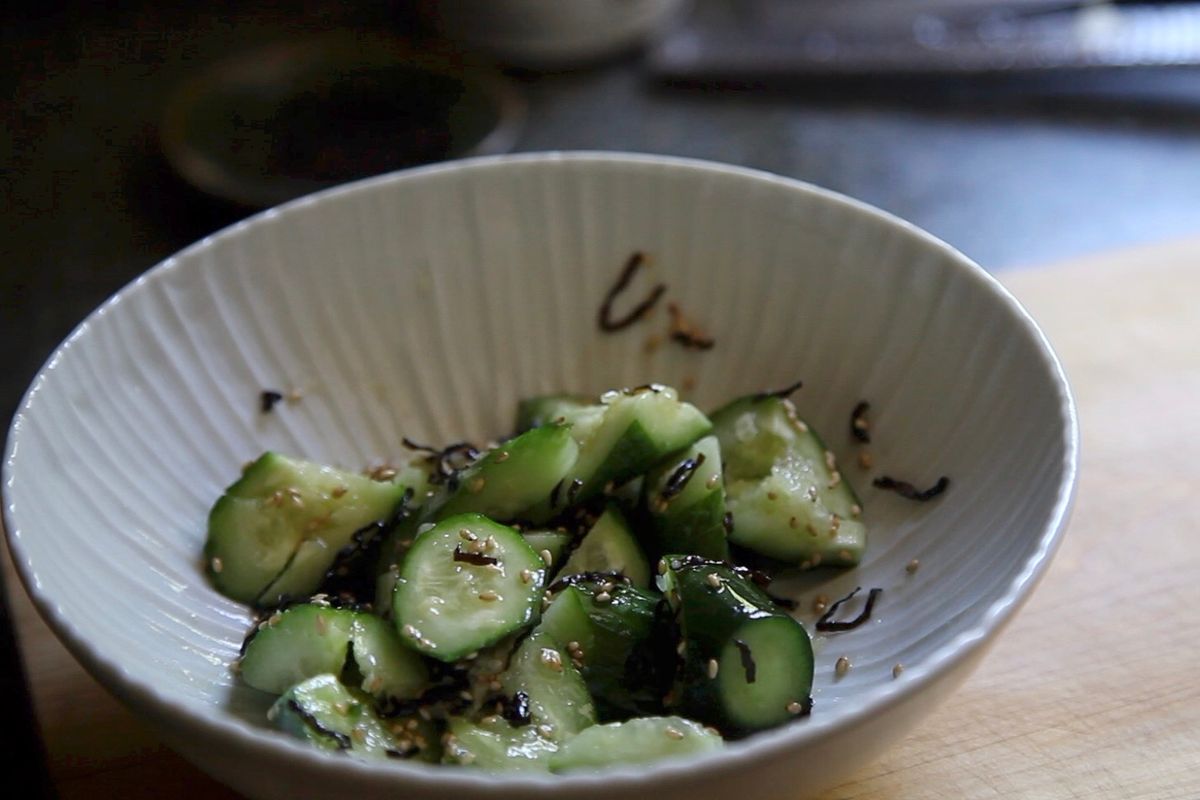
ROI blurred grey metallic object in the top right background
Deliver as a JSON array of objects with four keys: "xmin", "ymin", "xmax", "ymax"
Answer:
[{"xmin": 649, "ymin": 0, "xmax": 1200, "ymax": 80}]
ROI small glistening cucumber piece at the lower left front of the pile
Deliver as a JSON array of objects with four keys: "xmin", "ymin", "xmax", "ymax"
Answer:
[{"xmin": 266, "ymin": 675, "xmax": 407, "ymax": 758}]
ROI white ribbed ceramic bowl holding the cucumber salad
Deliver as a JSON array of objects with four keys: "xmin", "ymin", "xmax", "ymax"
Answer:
[{"xmin": 4, "ymin": 154, "xmax": 1076, "ymax": 800}]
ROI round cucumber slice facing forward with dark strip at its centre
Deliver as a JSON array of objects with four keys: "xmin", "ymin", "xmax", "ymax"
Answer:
[{"xmin": 392, "ymin": 513, "xmax": 546, "ymax": 661}]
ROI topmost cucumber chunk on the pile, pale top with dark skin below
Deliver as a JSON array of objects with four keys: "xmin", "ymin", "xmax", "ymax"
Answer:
[{"xmin": 530, "ymin": 384, "xmax": 713, "ymax": 522}]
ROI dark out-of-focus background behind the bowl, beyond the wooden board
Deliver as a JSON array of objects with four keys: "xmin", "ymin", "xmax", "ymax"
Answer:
[{"xmin": 7, "ymin": 0, "xmax": 1200, "ymax": 429}]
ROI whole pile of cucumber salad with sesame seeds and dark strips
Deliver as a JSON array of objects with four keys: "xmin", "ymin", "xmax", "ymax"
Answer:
[{"xmin": 205, "ymin": 385, "xmax": 866, "ymax": 772}]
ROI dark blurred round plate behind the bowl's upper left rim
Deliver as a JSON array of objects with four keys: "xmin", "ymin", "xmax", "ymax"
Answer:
[{"xmin": 161, "ymin": 34, "xmax": 524, "ymax": 207}]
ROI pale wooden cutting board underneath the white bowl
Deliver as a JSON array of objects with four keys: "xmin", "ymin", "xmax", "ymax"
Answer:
[{"xmin": 4, "ymin": 240, "xmax": 1200, "ymax": 800}]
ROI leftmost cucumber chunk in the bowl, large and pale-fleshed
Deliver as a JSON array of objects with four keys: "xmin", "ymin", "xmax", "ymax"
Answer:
[{"xmin": 204, "ymin": 452, "xmax": 404, "ymax": 606}]
